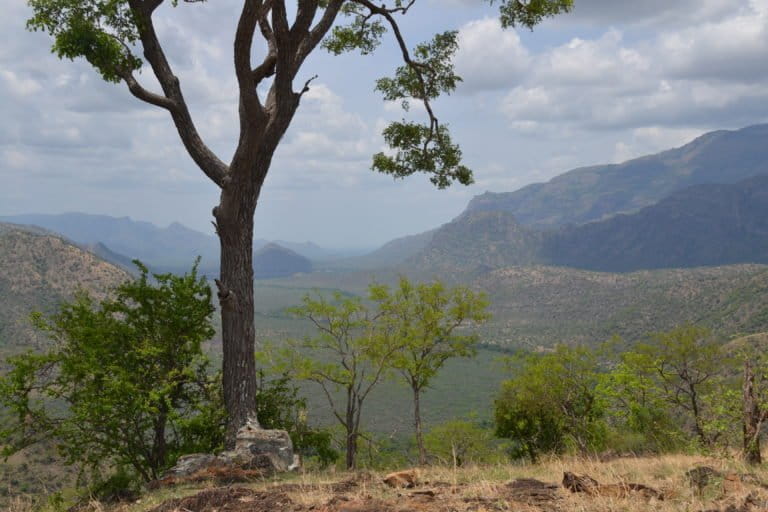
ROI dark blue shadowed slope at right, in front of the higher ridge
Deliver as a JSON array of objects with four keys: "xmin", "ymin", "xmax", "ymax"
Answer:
[{"xmin": 541, "ymin": 176, "xmax": 768, "ymax": 272}]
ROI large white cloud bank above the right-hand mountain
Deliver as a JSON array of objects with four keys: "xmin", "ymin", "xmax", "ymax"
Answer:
[{"xmin": 492, "ymin": 4, "xmax": 768, "ymax": 134}]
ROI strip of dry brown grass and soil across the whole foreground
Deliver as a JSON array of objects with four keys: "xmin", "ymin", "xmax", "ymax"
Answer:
[{"xmin": 9, "ymin": 455, "xmax": 768, "ymax": 512}]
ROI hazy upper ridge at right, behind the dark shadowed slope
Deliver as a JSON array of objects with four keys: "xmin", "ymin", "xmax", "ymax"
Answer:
[{"xmin": 467, "ymin": 125, "xmax": 768, "ymax": 228}]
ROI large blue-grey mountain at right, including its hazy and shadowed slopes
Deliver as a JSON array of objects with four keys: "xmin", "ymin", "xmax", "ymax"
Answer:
[{"xmin": 358, "ymin": 125, "xmax": 768, "ymax": 273}]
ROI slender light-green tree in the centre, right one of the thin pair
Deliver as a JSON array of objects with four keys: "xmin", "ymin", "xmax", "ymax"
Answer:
[{"xmin": 371, "ymin": 277, "xmax": 490, "ymax": 465}]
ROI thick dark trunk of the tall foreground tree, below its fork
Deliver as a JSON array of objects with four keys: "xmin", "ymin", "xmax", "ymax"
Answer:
[{"xmin": 214, "ymin": 185, "xmax": 257, "ymax": 448}]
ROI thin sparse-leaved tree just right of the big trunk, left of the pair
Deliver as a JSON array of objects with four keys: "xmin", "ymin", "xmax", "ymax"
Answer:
[{"xmin": 268, "ymin": 293, "xmax": 397, "ymax": 469}]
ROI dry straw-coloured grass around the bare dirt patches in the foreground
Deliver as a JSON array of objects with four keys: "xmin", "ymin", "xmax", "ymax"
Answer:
[{"xmin": 15, "ymin": 455, "xmax": 768, "ymax": 512}]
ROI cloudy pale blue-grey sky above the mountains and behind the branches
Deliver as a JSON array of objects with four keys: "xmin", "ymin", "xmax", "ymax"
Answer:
[{"xmin": 0, "ymin": 0, "xmax": 768, "ymax": 248}]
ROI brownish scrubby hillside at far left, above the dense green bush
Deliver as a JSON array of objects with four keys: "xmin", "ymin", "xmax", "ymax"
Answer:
[{"xmin": 0, "ymin": 224, "xmax": 129, "ymax": 354}]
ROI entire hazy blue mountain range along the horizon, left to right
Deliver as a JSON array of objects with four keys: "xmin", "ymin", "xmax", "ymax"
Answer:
[{"xmin": 0, "ymin": 125, "xmax": 768, "ymax": 276}]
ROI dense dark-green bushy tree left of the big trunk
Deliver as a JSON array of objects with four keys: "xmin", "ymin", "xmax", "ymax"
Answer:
[{"xmin": 0, "ymin": 262, "xmax": 224, "ymax": 481}]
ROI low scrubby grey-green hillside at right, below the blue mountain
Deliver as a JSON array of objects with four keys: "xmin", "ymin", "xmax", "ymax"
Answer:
[{"xmin": 473, "ymin": 265, "xmax": 768, "ymax": 348}]
